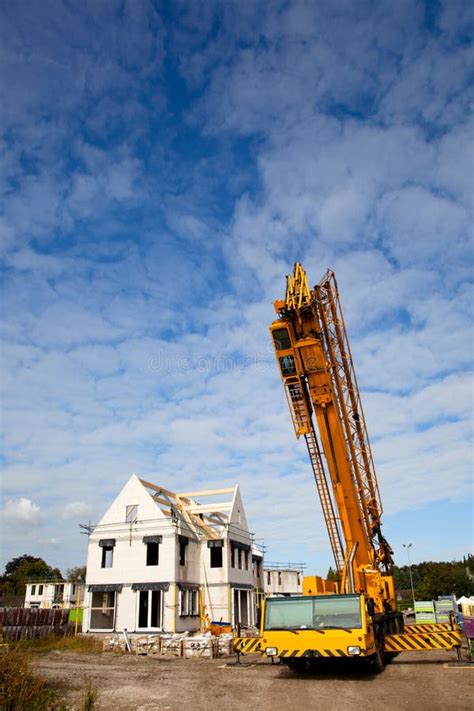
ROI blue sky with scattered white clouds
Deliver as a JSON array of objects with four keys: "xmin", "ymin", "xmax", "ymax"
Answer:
[{"xmin": 0, "ymin": 0, "xmax": 473, "ymax": 573}]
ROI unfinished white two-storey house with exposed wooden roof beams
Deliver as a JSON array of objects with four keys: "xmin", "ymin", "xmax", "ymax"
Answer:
[{"xmin": 83, "ymin": 475, "xmax": 263, "ymax": 633}]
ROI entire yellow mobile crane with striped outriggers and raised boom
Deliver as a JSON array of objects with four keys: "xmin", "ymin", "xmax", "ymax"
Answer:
[{"xmin": 234, "ymin": 263, "xmax": 461, "ymax": 671}]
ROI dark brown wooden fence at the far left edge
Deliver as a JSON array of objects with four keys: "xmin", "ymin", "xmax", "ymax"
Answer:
[{"xmin": 0, "ymin": 607, "xmax": 74, "ymax": 642}]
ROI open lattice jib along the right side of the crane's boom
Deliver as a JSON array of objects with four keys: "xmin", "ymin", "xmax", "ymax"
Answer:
[{"xmin": 312, "ymin": 271, "xmax": 392, "ymax": 569}]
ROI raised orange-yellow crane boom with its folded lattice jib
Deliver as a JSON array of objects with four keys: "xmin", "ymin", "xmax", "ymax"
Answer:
[{"xmin": 270, "ymin": 263, "xmax": 395, "ymax": 609}]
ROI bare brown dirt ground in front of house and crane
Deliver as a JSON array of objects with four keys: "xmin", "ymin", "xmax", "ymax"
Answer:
[{"xmin": 35, "ymin": 652, "xmax": 474, "ymax": 711}]
